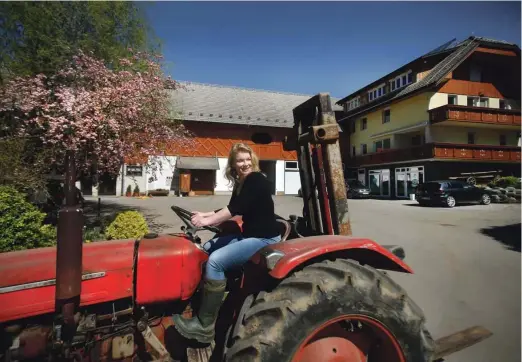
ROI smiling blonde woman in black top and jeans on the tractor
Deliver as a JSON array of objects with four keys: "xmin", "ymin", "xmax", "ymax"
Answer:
[{"xmin": 173, "ymin": 143, "xmax": 281, "ymax": 343}]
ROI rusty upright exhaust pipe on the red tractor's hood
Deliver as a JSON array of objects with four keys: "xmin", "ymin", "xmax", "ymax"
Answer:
[{"xmin": 55, "ymin": 151, "xmax": 83, "ymax": 341}]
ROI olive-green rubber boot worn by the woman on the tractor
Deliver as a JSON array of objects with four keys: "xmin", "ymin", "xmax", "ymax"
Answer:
[{"xmin": 172, "ymin": 279, "xmax": 227, "ymax": 343}]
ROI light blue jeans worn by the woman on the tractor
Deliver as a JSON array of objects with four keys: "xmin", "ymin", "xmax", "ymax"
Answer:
[{"xmin": 203, "ymin": 235, "xmax": 281, "ymax": 280}]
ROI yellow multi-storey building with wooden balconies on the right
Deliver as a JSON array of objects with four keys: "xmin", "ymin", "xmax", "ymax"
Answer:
[{"xmin": 337, "ymin": 37, "xmax": 521, "ymax": 198}]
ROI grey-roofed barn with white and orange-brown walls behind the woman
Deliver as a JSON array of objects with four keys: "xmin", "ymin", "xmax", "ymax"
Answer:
[{"xmin": 89, "ymin": 82, "xmax": 342, "ymax": 196}]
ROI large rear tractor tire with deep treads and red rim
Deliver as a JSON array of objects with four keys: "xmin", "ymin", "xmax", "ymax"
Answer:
[{"xmin": 225, "ymin": 259, "xmax": 435, "ymax": 362}]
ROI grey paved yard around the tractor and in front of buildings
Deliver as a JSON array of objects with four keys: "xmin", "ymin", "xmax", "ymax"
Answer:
[{"xmin": 87, "ymin": 196, "xmax": 521, "ymax": 362}]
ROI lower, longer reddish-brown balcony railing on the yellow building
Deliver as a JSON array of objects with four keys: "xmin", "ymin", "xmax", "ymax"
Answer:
[{"xmin": 347, "ymin": 143, "xmax": 520, "ymax": 167}]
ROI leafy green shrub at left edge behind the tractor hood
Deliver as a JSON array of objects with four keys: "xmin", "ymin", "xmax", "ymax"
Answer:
[{"xmin": 0, "ymin": 186, "xmax": 56, "ymax": 252}]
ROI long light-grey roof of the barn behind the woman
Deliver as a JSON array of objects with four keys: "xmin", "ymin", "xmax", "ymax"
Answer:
[{"xmin": 171, "ymin": 82, "xmax": 342, "ymax": 128}]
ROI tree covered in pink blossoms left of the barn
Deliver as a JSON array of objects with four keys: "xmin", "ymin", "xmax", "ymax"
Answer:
[{"xmin": 0, "ymin": 52, "xmax": 191, "ymax": 182}]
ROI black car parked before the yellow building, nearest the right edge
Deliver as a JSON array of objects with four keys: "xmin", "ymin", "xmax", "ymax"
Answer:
[{"xmin": 415, "ymin": 180, "xmax": 491, "ymax": 207}]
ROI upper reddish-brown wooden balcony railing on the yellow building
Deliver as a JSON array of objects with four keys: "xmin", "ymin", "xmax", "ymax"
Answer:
[{"xmin": 429, "ymin": 104, "xmax": 520, "ymax": 126}]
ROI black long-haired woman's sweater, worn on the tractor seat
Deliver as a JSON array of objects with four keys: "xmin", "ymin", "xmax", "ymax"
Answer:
[{"xmin": 228, "ymin": 172, "xmax": 279, "ymax": 238}]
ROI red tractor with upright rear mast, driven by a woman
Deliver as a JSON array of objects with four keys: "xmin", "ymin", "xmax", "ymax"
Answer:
[{"xmin": 0, "ymin": 94, "xmax": 491, "ymax": 362}]
